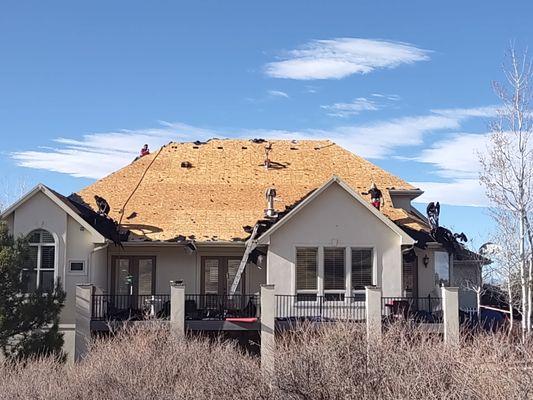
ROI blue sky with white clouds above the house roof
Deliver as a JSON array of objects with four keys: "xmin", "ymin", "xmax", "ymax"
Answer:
[{"xmin": 0, "ymin": 0, "xmax": 533, "ymax": 248}]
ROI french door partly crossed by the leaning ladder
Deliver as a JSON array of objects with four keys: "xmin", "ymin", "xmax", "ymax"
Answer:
[{"xmin": 201, "ymin": 256, "xmax": 245, "ymax": 295}]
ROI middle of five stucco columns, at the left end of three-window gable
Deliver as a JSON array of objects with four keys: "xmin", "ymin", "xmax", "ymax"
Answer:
[{"xmin": 261, "ymin": 285, "xmax": 276, "ymax": 372}]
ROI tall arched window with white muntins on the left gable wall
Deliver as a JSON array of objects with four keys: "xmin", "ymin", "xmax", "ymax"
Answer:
[{"xmin": 23, "ymin": 229, "xmax": 56, "ymax": 292}]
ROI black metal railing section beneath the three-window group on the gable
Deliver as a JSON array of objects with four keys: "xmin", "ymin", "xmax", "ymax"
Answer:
[{"xmin": 276, "ymin": 294, "xmax": 366, "ymax": 322}]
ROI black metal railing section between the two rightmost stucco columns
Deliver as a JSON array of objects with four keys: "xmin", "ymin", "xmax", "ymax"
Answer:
[{"xmin": 381, "ymin": 296, "xmax": 442, "ymax": 322}]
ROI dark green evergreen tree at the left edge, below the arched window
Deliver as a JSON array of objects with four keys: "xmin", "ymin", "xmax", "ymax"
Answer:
[{"xmin": 0, "ymin": 222, "xmax": 66, "ymax": 360}]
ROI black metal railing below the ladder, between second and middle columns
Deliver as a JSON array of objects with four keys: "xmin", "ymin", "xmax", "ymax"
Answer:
[{"xmin": 185, "ymin": 294, "xmax": 260, "ymax": 321}]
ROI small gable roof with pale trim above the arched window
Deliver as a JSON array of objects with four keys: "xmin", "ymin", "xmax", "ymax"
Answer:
[{"xmin": 0, "ymin": 184, "xmax": 107, "ymax": 243}]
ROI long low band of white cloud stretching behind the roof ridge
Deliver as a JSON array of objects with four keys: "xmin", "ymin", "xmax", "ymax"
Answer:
[{"xmin": 11, "ymin": 104, "xmax": 494, "ymax": 205}]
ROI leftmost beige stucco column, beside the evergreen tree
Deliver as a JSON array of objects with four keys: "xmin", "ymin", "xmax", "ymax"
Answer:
[{"xmin": 74, "ymin": 284, "xmax": 94, "ymax": 361}]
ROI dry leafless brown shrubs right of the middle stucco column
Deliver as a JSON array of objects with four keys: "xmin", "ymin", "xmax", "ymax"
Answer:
[{"xmin": 273, "ymin": 324, "xmax": 533, "ymax": 399}]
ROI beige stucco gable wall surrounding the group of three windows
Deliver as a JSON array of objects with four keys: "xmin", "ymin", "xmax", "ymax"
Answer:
[{"xmin": 267, "ymin": 185, "xmax": 402, "ymax": 296}]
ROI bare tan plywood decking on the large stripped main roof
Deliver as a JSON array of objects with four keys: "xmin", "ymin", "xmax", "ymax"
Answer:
[{"xmin": 77, "ymin": 139, "xmax": 424, "ymax": 241}]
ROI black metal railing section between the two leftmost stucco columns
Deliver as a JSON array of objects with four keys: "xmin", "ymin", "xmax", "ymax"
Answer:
[{"xmin": 92, "ymin": 294, "xmax": 170, "ymax": 321}]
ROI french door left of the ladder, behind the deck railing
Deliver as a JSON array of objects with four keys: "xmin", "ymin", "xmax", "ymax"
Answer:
[{"xmin": 111, "ymin": 256, "xmax": 155, "ymax": 296}]
